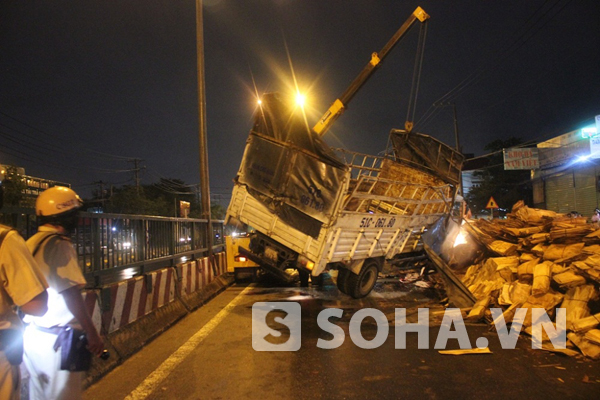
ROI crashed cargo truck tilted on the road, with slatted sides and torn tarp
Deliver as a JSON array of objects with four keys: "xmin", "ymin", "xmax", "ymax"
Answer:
[{"xmin": 226, "ymin": 9, "xmax": 463, "ymax": 298}]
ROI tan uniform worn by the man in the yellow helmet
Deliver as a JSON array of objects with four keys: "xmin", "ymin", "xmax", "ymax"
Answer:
[{"xmin": 24, "ymin": 226, "xmax": 86, "ymax": 399}]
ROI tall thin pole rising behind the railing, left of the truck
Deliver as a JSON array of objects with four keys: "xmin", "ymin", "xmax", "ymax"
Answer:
[{"xmin": 196, "ymin": 0, "xmax": 215, "ymax": 260}]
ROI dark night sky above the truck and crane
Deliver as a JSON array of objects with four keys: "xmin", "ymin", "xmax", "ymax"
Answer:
[{"xmin": 0, "ymin": 0, "xmax": 600, "ymax": 206}]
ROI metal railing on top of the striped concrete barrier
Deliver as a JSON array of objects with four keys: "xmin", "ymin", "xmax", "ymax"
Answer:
[{"xmin": 72, "ymin": 213, "xmax": 225, "ymax": 285}]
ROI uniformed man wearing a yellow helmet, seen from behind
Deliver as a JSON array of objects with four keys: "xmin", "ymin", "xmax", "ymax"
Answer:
[{"xmin": 25, "ymin": 186, "xmax": 104, "ymax": 400}]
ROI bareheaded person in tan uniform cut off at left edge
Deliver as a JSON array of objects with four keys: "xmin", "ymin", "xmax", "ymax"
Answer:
[{"xmin": 0, "ymin": 219, "xmax": 48, "ymax": 400}]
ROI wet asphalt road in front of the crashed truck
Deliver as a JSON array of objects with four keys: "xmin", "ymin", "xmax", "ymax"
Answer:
[{"xmin": 85, "ymin": 280, "xmax": 600, "ymax": 400}]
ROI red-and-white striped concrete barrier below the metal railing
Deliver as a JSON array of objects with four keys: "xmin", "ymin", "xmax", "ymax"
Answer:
[{"xmin": 84, "ymin": 252, "xmax": 233, "ymax": 386}]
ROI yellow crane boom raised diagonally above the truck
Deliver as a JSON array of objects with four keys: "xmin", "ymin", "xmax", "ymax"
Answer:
[{"xmin": 313, "ymin": 7, "xmax": 429, "ymax": 136}]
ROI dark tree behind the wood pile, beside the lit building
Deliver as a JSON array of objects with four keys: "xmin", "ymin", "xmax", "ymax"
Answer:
[{"xmin": 467, "ymin": 137, "xmax": 533, "ymax": 214}]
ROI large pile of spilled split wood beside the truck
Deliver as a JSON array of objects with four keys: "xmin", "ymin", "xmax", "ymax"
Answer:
[{"xmin": 461, "ymin": 202, "xmax": 600, "ymax": 360}]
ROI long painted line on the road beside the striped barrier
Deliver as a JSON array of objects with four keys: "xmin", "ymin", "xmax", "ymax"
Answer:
[{"xmin": 125, "ymin": 285, "xmax": 254, "ymax": 400}]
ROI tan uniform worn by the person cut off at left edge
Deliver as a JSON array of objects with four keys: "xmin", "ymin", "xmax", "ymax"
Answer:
[{"xmin": 0, "ymin": 227, "xmax": 47, "ymax": 399}]
